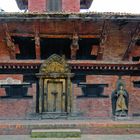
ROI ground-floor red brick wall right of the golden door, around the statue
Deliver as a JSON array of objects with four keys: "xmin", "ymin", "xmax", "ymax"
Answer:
[{"xmin": 73, "ymin": 75, "xmax": 140, "ymax": 117}]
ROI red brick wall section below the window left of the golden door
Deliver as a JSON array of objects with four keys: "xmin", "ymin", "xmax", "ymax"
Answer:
[{"xmin": 0, "ymin": 98, "xmax": 34, "ymax": 119}]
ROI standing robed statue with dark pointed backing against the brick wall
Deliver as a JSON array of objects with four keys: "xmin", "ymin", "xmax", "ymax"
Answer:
[{"xmin": 111, "ymin": 78, "xmax": 129, "ymax": 117}]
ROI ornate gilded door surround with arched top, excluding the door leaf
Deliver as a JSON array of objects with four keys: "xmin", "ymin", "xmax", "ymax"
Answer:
[{"xmin": 36, "ymin": 54, "xmax": 74, "ymax": 115}]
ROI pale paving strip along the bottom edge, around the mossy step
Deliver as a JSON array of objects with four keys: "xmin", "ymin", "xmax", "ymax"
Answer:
[{"xmin": 0, "ymin": 135, "xmax": 140, "ymax": 140}]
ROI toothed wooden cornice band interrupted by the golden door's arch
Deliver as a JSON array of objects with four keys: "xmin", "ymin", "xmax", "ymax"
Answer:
[{"xmin": 0, "ymin": 60, "xmax": 140, "ymax": 71}]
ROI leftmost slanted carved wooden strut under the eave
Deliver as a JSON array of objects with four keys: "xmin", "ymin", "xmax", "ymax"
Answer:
[{"xmin": 3, "ymin": 23, "xmax": 16, "ymax": 59}]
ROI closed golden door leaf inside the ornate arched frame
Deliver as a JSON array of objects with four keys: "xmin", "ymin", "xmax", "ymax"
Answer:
[{"xmin": 44, "ymin": 81, "xmax": 66, "ymax": 113}]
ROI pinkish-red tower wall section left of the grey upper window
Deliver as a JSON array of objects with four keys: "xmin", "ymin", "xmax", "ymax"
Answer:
[{"xmin": 28, "ymin": 0, "xmax": 47, "ymax": 13}]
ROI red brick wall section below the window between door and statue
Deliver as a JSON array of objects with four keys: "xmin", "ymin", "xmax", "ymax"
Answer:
[{"xmin": 77, "ymin": 98, "xmax": 111, "ymax": 118}]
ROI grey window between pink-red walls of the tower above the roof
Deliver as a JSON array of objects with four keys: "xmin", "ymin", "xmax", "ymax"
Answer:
[{"xmin": 47, "ymin": 0, "xmax": 62, "ymax": 12}]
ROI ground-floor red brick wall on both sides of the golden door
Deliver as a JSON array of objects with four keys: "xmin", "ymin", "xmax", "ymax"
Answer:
[{"xmin": 0, "ymin": 75, "xmax": 140, "ymax": 119}]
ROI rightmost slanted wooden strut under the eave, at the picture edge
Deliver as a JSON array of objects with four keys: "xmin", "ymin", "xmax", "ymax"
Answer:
[{"xmin": 122, "ymin": 23, "xmax": 140, "ymax": 60}]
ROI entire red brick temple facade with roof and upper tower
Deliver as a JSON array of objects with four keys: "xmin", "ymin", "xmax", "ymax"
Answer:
[{"xmin": 0, "ymin": 0, "xmax": 140, "ymax": 119}]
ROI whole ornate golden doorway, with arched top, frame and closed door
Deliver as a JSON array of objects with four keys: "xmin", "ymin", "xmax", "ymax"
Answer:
[{"xmin": 37, "ymin": 54, "xmax": 73, "ymax": 116}]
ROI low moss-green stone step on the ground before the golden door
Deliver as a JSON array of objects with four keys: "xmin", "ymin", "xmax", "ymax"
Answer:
[{"xmin": 31, "ymin": 129, "xmax": 81, "ymax": 138}]
